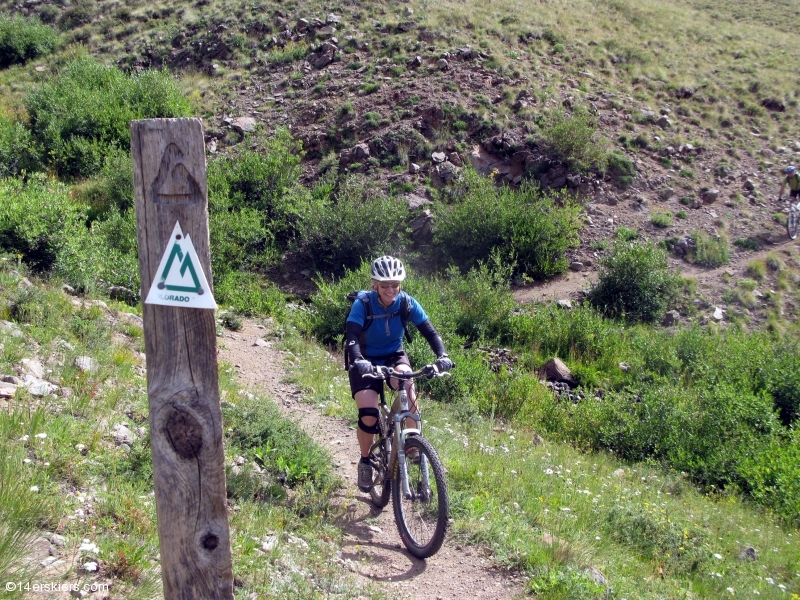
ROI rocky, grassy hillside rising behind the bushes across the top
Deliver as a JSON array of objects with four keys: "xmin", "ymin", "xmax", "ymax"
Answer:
[{"xmin": 0, "ymin": 0, "xmax": 800, "ymax": 322}]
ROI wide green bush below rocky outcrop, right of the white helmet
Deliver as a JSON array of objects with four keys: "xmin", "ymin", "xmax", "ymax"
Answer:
[{"xmin": 434, "ymin": 169, "xmax": 581, "ymax": 278}]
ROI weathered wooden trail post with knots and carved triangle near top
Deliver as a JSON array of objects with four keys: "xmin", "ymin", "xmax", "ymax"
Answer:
[{"xmin": 131, "ymin": 119, "xmax": 233, "ymax": 600}]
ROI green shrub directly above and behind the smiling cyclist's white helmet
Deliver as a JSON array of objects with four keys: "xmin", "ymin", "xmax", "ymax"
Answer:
[{"xmin": 293, "ymin": 176, "xmax": 407, "ymax": 275}]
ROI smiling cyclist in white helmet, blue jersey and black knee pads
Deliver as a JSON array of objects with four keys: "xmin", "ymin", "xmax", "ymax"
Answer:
[{"xmin": 345, "ymin": 256, "xmax": 453, "ymax": 492}]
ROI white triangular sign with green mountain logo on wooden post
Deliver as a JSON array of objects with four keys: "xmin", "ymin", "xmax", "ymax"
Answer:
[{"xmin": 144, "ymin": 221, "xmax": 217, "ymax": 308}]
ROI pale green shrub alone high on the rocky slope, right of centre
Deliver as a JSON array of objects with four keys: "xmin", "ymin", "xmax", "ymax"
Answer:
[{"xmin": 541, "ymin": 107, "xmax": 608, "ymax": 171}]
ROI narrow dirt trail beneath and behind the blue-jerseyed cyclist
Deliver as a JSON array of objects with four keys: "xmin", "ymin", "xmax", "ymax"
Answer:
[{"xmin": 219, "ymin": 321, "xmax": 523, "ymax": 600}]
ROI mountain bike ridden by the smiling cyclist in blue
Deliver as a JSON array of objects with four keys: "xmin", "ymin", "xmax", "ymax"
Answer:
[{"xmin": 366, "ymin": 365, "xmax": 450, "ymax": 558}]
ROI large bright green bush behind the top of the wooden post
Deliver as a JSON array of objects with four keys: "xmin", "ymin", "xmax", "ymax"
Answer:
[{"xmin": 24, "ymin": 54, "xmax": 192, "ymax": 179}]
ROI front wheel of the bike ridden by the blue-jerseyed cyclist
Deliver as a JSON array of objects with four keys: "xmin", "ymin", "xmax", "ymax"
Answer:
[{"xmin": 392, "ymin": 436, "xmax": 450, "ymax": 558}]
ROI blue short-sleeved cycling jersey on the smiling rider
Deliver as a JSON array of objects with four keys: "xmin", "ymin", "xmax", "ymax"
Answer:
[{"xmin": 347, "ymin": 290, "xmax": 428, "ymax": 362}]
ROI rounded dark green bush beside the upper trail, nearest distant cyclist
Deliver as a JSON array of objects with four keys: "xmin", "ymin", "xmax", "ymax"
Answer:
[{"xmin": 589, "ymin": 241, "xmax": 680, "ymax": 322}]
